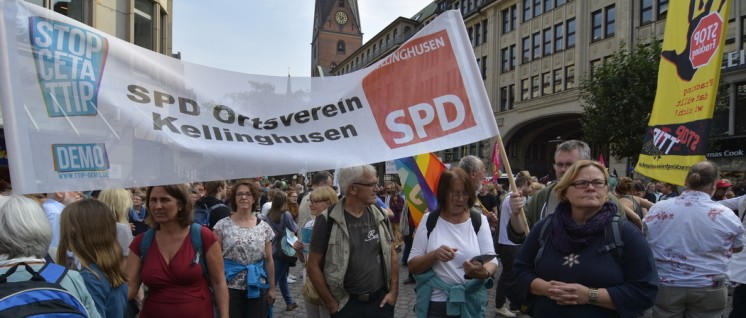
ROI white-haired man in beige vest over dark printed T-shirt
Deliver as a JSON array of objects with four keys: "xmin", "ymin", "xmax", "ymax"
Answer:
[{"xmin": 306, "ymin": 165, "xmax": 399, "ymax": 318}]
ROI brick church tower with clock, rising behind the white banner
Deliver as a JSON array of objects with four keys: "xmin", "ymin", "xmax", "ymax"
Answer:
[{"xmin": 311, "ymin": 0, "xmax": 363, "ymax": 77}]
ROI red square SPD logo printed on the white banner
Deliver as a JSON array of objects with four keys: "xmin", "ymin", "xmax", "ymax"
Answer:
[{"xmin": 363, "ymin": 31, "xmax": 476, "ymax": 148}]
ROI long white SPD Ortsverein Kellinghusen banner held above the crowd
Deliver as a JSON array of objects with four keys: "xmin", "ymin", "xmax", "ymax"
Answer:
[{"xmin": 0, "ymin": 0, "xmax": 499, "ymax": 193}]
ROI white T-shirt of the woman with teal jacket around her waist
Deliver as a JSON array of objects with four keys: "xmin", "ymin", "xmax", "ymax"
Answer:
[{"xmin": 407, "ymin": 213, "xmax": 497, "ymax": 302}]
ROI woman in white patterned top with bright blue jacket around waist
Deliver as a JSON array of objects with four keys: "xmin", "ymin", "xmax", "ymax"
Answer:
[{"xmin": 214, "ymin": 180, "xmax": 275, "ymax": 317}]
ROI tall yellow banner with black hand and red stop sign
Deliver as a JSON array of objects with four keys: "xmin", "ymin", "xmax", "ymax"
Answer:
[{"xmin": 635, "ymin": 0, "xmax": 730, "ymax": 185}]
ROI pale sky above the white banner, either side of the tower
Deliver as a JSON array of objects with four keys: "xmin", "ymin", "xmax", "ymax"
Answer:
[{"xmin": 173, "ymin": 0, "xmax": 432, "ymax": 77}]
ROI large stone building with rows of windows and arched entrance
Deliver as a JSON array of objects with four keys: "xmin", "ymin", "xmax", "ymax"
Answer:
[{"xmin": 332, "ymin": 0, "xmax": 746, "ymax": 180}]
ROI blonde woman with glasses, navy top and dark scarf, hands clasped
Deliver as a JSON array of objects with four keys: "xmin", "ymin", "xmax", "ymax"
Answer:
[{"xmin": 513, "ymin": 160, "xmax": 658, "ymax": 318}]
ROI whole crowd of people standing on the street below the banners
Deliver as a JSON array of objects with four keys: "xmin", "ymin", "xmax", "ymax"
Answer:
[{"xmin": 0, "ymin": 140, "xmax": 746, "ymax": 318}]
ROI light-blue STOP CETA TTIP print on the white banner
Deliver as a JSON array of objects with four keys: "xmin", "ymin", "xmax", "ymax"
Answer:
[{"xmin": 29, "ymin": 17, "xmax": 109, "ymax": 117}]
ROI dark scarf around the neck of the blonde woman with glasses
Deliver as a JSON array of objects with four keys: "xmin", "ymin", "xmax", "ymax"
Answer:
[{"xmin": 549, "ymin": 202, "xmax": 617, "ymax": 255}]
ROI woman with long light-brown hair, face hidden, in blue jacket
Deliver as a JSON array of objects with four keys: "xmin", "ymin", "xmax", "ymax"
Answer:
[{"xmin": 57, "ymin": 199, "xmax": 127, "ymax": 317}]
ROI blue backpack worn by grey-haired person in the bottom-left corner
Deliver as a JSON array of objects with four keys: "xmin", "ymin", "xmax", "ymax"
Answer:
[{"xmin": 0, "ymin": 263, "xmax": 88, "ymax": 318}]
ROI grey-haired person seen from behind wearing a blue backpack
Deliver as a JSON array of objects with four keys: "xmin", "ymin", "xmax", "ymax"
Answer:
[{"xmin": 0, "ymin": 195, "xmax": 101, "ymax": 318}]
